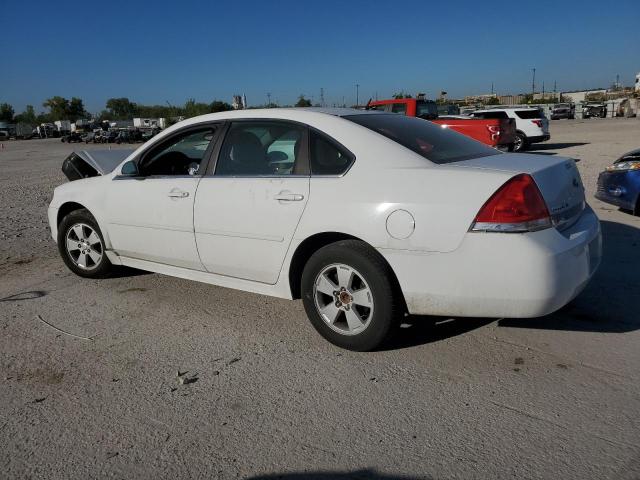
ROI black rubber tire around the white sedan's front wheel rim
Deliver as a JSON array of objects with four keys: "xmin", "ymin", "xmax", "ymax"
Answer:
[{"xmin": 58, "ymin": 209, "xmax": 114, "ymax": 278}]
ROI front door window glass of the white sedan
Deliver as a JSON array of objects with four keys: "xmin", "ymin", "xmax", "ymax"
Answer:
[{"xmin": 138, "ymin": 126, "xmax": 215, "ymax": 176}]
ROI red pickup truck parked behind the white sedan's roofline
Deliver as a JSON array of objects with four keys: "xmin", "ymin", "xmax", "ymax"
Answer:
[{"xmin": 367, "ymin": 98, "xmax": 516, "ymax": 152}]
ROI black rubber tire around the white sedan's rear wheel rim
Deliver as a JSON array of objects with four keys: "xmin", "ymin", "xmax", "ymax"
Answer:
[{"xmin": 301, "ymin": 240, "xmax": 402, "ymax": 352}]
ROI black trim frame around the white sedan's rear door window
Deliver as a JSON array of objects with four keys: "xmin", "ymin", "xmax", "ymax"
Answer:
[{"xmin": 204, "ymin": 118, "xmax": 311, "ymax": 178}]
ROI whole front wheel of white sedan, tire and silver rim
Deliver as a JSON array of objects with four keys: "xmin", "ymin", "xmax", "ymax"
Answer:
[{"xmin": 58, "ymin": 209, "xmax": 113, "ymax": 278}]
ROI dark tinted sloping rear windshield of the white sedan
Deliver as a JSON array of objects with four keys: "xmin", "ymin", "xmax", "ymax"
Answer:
[{"xmin": 344, "ymin": 114, "xmax": 500, "ymax": 165}]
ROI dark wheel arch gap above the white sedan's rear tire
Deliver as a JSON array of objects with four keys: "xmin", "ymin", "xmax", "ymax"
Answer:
[{"xmin": 289, "ymin": 232, "xmax": 406, "ymax": 311}]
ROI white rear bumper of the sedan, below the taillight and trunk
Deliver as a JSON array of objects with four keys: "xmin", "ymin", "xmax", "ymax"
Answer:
[{"xmin": 380, "ymin": 207, "xmax": 602, "ymax": 318}]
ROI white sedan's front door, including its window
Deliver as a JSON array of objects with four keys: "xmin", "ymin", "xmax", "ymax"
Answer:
[{"xmin": 106, "ymin": 125, "xmax": 216, "ymax": 270}]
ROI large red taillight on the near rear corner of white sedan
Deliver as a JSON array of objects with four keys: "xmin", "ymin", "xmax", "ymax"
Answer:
[{"xmin": 469, "ymin": 173, "xmax": 551, "ymax": 233}]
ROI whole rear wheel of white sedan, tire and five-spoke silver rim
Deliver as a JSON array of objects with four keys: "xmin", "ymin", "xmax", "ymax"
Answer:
[{"xmin": 302, "ymin": 240, "xmax": 400, "ymax": 351}]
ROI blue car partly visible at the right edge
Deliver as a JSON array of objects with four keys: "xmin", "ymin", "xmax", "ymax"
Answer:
[{"xmin": 596, "ymin": 148, "xmax": 640, "ymax": 215}]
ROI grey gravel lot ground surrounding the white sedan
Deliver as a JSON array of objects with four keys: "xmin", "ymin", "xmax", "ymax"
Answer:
[{"xmin": 0, "ymin": 119, "xmax": 640, "ymax": 479}]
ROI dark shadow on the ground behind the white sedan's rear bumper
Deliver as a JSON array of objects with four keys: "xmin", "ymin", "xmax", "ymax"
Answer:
[{"xmin": 498, "ymin": 221, "xmax": 640, "ymax": 333}]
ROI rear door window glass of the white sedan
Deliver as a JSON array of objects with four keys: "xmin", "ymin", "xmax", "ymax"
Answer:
[{"xmin": 215, "ymin": 121, "xmax": 305, "ymax": 176}]
